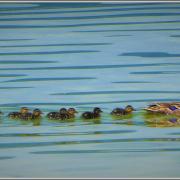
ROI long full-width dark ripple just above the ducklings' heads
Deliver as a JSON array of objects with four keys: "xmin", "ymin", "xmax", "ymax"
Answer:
[{"xmin": 0, "ymin": 98, "xmax": 180, "ymax": 107}]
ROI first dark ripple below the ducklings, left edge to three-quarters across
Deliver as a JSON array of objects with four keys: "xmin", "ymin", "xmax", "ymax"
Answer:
[{"xmin": 0, "ymin": 130, "xmax": 136, "ymax": 137}]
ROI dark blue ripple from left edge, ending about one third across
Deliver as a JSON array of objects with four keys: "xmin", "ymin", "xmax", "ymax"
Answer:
[{"xmin": 0, "ymin": 60, "xmax": 57, "ymax": 64}]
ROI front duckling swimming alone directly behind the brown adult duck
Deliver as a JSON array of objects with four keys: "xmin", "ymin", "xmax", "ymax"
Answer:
[{"xmin": 111, "ymin": 105, "xmax": 135, "ymax": 116}]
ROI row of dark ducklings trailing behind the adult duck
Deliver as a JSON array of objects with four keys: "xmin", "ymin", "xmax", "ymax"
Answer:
[{"xmin": 0, "ymin": 105, "xmax": 134, "ymax": 120}]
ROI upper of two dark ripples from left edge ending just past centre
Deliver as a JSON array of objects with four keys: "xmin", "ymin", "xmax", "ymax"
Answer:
[{"xmin": 0, "ymin": 43, "xmax": 112, "ymax": 47}]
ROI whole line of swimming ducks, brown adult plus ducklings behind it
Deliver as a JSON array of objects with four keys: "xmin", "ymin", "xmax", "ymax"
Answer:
[{"xmin": 1, "ymin": 102, "xmax": 180, "ymax": 120}]
